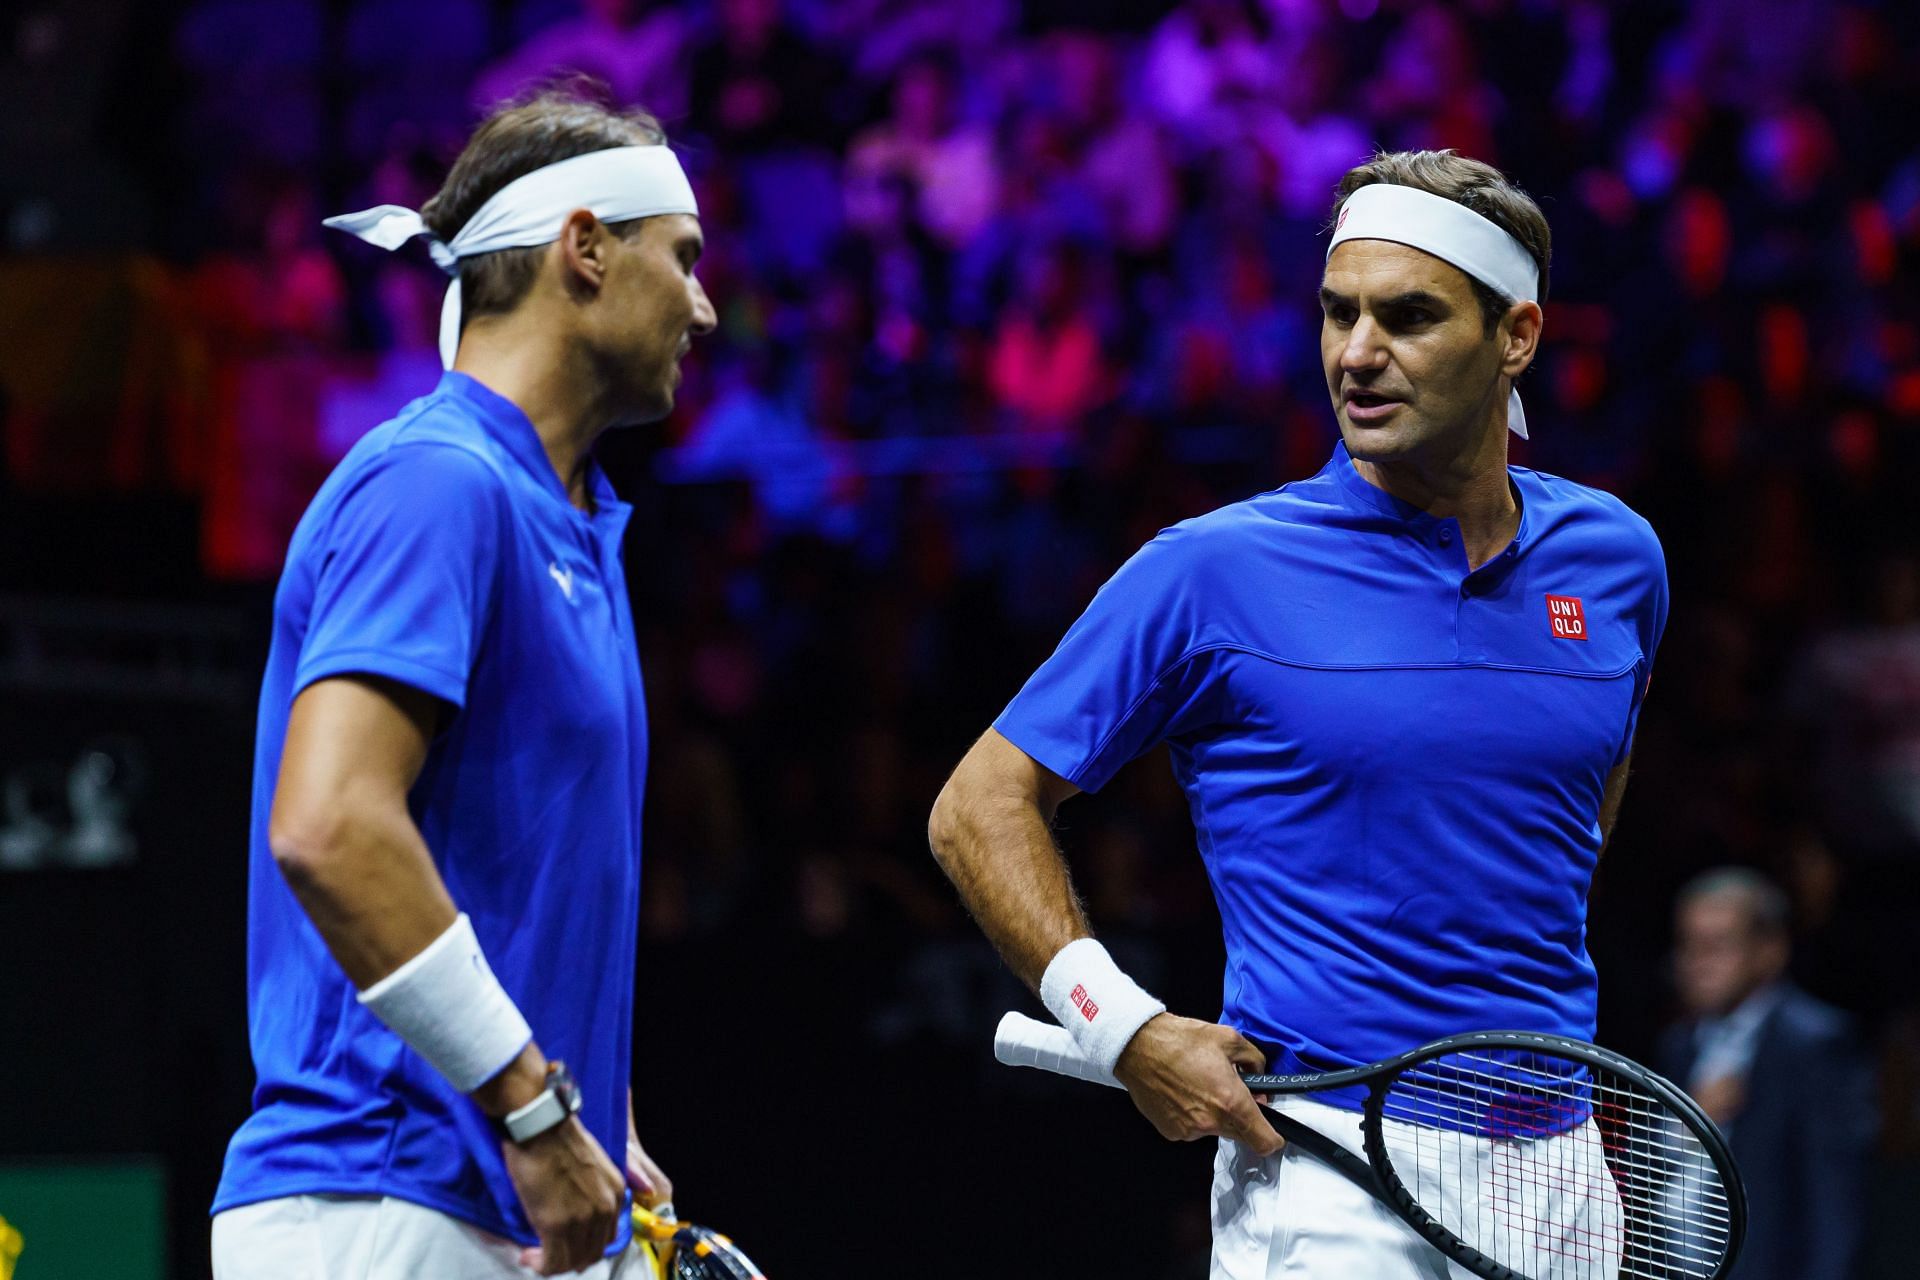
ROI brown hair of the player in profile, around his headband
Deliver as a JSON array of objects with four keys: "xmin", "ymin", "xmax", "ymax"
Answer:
[{"xmin": 420, "ymin": 81, "xmax": 666, "ymax": 326}]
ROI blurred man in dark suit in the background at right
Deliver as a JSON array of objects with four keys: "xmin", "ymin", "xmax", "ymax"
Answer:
[{"xmin": 1661, "ymin": 869, "xmax": 1874, "ymax": 1280}]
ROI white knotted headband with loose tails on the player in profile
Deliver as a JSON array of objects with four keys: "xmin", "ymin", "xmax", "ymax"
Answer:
[{"xmin": 324, "ymin": 146, "xmax": 701, "ymax": 368}]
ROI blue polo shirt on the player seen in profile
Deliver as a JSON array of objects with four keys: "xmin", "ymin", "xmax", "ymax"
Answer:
[{"xmin": 213, "ymin": 372, "xmax": 647, "ymax": 1249}]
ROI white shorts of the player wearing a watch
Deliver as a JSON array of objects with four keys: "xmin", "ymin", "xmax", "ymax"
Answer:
[{"xmin": 213, "ymin": 1196, "xmax": 651, "ymax": 1280}]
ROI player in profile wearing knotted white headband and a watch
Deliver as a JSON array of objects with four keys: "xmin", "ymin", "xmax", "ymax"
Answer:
[{"xmin": 213, "ymin": 94, "xmax": 714, "ymax": 1280}]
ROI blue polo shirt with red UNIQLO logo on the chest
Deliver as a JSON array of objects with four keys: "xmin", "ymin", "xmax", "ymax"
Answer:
[{"xmin": 995, "ymin": 447, "xmax": 1667, "ymax": 1073}]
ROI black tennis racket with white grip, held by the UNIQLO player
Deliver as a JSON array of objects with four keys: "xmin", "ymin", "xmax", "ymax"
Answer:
[{"xmin": 993, "ymin": 1013, "xmax": 1747, "ymax": 1280}]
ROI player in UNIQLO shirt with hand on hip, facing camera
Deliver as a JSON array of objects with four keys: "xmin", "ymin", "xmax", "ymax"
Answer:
[{"xmin": 929, "ymin": 152, "xmax": 1667, "ymax": 1280}]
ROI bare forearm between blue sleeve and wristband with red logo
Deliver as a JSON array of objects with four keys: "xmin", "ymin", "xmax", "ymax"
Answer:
[{"xmin": 927, "ymin": 756, "xmax": 1089, "ymax": 990}]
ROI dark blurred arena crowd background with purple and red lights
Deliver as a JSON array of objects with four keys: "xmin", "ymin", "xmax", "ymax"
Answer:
[{"xmin": 0, "ymin": 0, "xmax": 1920, "ymax": 1280}]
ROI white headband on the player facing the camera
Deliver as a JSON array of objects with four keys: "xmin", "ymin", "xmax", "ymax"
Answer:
[{"xmin": 1327, "ymin": 182, "xmax": 1540, "ymax": 439}]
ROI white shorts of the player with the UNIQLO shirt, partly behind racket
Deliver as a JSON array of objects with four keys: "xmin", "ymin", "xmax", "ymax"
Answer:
[{"xmin": 1212, "ymin": 1098, "xmax": 1620, "ymax": 1280}]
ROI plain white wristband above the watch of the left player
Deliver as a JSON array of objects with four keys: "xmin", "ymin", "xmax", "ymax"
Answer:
[{"xmin": 359, "ymin": 912, "xmax": 534, "ymax": 1094}]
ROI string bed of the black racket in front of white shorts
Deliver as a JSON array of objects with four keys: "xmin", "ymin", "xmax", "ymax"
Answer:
[{"xmin": 1380, "ymin": 1050, "xmax": 1734, "ymax": 1280}]
